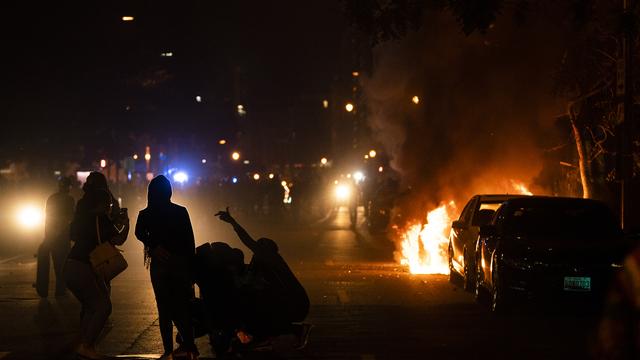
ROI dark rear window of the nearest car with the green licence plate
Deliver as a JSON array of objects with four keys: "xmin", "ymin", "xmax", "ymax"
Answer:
[{"xmin": 504, "ymin": 201, "xmax": 618, "ymax": 239}]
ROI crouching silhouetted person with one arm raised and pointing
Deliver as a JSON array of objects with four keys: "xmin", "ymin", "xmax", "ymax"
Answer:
[{"xmin": 216, "ymin": 208, "xmax": 309, "ymax": 336}]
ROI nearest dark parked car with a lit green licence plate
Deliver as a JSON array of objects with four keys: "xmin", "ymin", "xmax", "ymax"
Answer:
[{"xmin": 476, "ymin": 196, "xmax": 627, "ymax": 312}]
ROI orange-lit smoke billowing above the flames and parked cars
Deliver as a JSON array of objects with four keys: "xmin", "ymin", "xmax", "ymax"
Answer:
[{"xmin": 362, "ymin": 8, "xmax": 564, "ymax": 216}]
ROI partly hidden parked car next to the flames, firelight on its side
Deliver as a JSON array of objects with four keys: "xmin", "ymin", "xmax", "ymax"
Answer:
[{"xmin": 449, "ymin": 194, "xmax": 523, "ymax": 291}]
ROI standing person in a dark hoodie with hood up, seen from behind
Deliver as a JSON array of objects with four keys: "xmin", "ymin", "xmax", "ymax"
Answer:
[{"xmin": 135, "ymin": 175, "xmax": 198, "ymax": 359}]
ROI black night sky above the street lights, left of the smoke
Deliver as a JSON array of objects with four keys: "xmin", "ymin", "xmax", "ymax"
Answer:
[{"xmin": 0, "ymin": 1, "xmax": 351, "ymax": 166}]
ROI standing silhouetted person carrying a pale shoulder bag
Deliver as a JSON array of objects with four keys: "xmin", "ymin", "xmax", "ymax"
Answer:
[{"xmin": 64, "ymin": 190, "xmax": 129, "ymax": 359}]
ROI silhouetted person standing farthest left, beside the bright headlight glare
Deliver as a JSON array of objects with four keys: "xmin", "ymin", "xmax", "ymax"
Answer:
[{"xmin": 43, "ymin": 177, "xmax": 76, "ymax": 296}]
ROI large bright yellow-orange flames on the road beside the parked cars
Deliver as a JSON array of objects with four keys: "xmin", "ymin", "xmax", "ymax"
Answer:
[{"xmin": 400, "ymin": 201, "xmax": 456, "ymax": 274}]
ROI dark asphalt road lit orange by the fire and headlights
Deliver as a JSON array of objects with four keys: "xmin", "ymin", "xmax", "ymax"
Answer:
[{"xmin": 0, "ymin": 209, "xmax": 597, "ymax": 360}]
